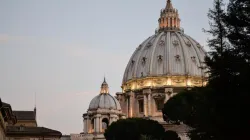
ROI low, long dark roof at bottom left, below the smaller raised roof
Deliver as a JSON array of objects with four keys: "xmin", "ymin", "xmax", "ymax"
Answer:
[{"xmin": 6, "ymin": 126, "xmax": 62, "ymax": 137}]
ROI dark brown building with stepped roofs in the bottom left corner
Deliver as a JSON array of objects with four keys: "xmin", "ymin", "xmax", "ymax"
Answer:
[{"xmin": 0, "ymin": 99, "xmax": 62, "ymax": 140}]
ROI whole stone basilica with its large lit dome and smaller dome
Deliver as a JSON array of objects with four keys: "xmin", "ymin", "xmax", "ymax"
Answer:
[{"xmin": 76, "ymin": 0, "xmax": 207, "ymax": 140}]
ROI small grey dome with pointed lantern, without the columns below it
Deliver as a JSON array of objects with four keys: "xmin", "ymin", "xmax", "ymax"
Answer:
[{"xmin": 89, "ymin": 79, "xmax": 121, "ymax": 110}]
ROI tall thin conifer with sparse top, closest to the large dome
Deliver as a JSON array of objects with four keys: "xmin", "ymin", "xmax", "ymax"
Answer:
[{"xmin": 204, "ymin": 0, "xmax": 235, "ymax": 93}]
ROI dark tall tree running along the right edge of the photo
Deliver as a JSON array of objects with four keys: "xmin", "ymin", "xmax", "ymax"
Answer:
[{"xmin": 224, "ymin": 0, "xmax": 250, "ymax": 136}]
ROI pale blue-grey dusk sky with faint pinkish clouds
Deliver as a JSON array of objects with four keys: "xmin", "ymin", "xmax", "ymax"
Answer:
[{"xmin": 0, "ymin": 0, "xmax": 212, "ymax": 134}]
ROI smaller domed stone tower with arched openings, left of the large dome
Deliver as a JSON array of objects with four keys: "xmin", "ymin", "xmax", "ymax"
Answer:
[{"xmin": 79, "ymin": 78, "xmax": 125, "ymax": 140}]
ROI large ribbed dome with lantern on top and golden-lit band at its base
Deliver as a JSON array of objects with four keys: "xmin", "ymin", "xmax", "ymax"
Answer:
[{"xmin": 122, "ymin": 0, "xmax": 206, "ymax": 90}]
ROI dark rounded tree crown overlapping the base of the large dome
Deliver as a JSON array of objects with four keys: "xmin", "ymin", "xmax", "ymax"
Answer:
[{"xmin": 163, "ymin": 88, "xmax": 215, "ymax": 128}]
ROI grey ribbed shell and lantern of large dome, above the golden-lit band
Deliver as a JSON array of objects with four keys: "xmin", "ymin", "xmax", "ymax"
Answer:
[{"xmin": 122, "ymin": 0, "xmax": 206, "ymax": 86}]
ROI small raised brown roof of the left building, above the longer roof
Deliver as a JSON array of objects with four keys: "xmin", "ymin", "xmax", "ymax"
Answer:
[{"xmin": 13, "ymin": 111, "xmax": 36, "ymax": 120}]
